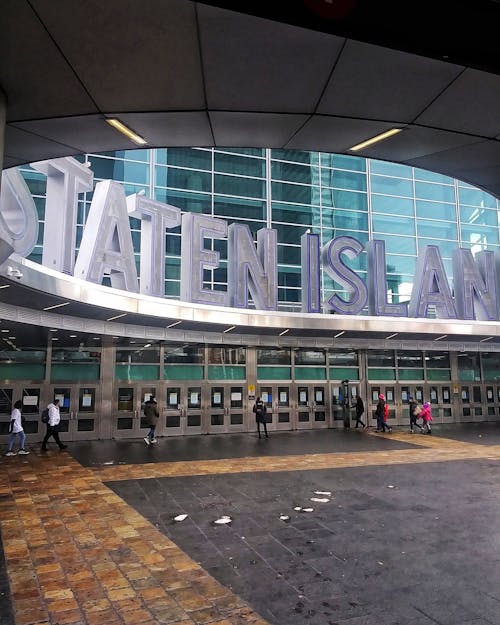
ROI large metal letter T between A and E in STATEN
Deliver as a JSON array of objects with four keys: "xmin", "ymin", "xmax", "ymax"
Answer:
[{"xmin": 127, "ymin": 193, "xmax": 181, "ymax": 297}]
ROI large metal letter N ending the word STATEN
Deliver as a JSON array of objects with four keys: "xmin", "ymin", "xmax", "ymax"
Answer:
[{"xmin": 227, "ymin": 224, "xmax": 278, "ymax": 310}]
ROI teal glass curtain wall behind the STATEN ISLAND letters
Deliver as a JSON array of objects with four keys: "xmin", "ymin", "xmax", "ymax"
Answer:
[{"xmin": 21, "ymin": 148, "xmax": 500, "ymax": 311}]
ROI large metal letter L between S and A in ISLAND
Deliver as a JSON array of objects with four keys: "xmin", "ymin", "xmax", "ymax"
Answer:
[{"xmin": 366, "ymin": 239, "xmax": 408, "ymax": 317}]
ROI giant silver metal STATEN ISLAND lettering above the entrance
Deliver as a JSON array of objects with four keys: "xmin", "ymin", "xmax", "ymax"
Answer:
[{"xmin": 0, "ymin": 158, "xmax": 500, "ymax": 321}]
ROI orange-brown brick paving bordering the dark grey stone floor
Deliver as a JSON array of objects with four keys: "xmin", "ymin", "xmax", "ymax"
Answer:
[{"xmin": 0, "ymin": 424, "xmax": 500, "ymax": 625}]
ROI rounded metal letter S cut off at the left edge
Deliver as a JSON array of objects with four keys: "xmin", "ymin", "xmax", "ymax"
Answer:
[{"xmin": 0, "ymin": 169, "xmax": 38, "ymax": 263}]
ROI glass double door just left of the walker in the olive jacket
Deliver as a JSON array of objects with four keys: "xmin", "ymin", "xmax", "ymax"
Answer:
[{"xmin": 113, "ymin": 385, "xmax": 156, "ymax": 438}]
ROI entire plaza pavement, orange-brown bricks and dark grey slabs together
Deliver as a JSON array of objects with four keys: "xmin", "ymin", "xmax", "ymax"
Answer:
[{"xmin": 0, "ymin": 424, "xmax": 500, "ymax": 625}]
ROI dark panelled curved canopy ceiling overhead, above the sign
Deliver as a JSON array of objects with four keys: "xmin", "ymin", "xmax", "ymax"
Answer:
[{"xmin": 0, "ymin": 0, "xmax": 500, "ymax": 196}]
